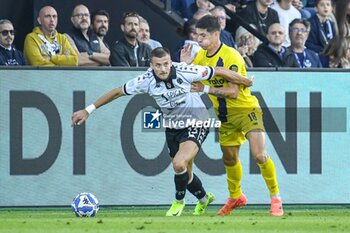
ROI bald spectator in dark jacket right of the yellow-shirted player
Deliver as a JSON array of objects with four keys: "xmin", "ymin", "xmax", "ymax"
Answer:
[{"xmin": 253, "ymin": 23, "xmax": 286, "ymax": 67}]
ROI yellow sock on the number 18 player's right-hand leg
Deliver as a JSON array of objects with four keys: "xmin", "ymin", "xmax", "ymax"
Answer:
[{"xmin": 258, "ymin": 156, "xmax": 279, "ymax": 195}]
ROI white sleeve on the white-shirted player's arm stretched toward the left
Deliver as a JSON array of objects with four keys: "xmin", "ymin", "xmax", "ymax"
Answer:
[{"xmin": 122, "ymin": 74, "xmax": 149, "ymax": 95}]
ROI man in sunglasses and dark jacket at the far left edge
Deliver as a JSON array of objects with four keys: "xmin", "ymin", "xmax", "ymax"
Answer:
[{"xmin": 0, "ymin": 19, "xmax": 26, "ymax": 66}]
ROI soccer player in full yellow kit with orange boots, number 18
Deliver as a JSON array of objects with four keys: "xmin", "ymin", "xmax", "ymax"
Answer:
[{"xmin": 181, "ymin": 16, "xmax": 283, "ymax": 216}]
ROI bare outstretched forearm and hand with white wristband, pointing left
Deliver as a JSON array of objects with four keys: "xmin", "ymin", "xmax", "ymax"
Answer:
[{"xmin": 72, "ymin": 87, "xmax": 124, "ymax": 127}]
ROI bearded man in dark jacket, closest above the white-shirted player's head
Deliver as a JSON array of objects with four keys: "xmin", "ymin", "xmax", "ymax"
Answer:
[{"xmin": 109, "ymin": 12, "xmax": 152, "ymax": 67}]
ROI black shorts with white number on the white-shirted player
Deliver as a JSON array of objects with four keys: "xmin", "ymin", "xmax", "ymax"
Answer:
[{"xmin": 165, "ymin": 127, "xmax": 209, "ymax": 158}]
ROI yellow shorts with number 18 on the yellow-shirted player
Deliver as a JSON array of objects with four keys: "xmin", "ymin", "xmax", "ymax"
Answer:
[{"xmin": 219, "ymin": 108, "xmax": 265, "ymax": 146}]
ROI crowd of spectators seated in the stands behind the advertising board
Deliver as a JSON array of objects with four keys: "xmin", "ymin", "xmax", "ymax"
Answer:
[{"xmin": 0, "ymin": 0, "xmax": 350, "ymax": 68}]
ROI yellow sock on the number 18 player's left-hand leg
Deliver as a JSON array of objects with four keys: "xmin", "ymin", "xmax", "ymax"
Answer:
[{"xmin": 225, "ymin": 160, "xmax": 243, "ymax": 199}]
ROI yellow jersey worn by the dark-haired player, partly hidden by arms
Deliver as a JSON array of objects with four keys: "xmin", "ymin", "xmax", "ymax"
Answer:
[{"xmin": 193, "ymin": 43, "xmax": 260, "ymax": 122}]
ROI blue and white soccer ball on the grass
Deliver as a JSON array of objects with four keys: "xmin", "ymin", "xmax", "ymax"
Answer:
[{"xmin": 72, "ymin": 193, "xmax": 100, "ymax": 217}]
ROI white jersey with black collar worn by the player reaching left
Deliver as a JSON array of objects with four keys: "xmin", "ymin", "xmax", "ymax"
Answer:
[{"xmin": 123, "ymin": 62, "xmax": 214, "ymax": 129}]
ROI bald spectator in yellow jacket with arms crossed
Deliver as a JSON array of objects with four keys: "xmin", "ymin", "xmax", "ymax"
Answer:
[{"xmin": 24, "ymin": 6, "xmax": 78, "ymax": 66}]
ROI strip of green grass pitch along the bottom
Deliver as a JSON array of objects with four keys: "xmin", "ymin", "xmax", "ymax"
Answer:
[{"xmin": 0, "ymin": 205, "xmax": 350, "ymax": 233}]
